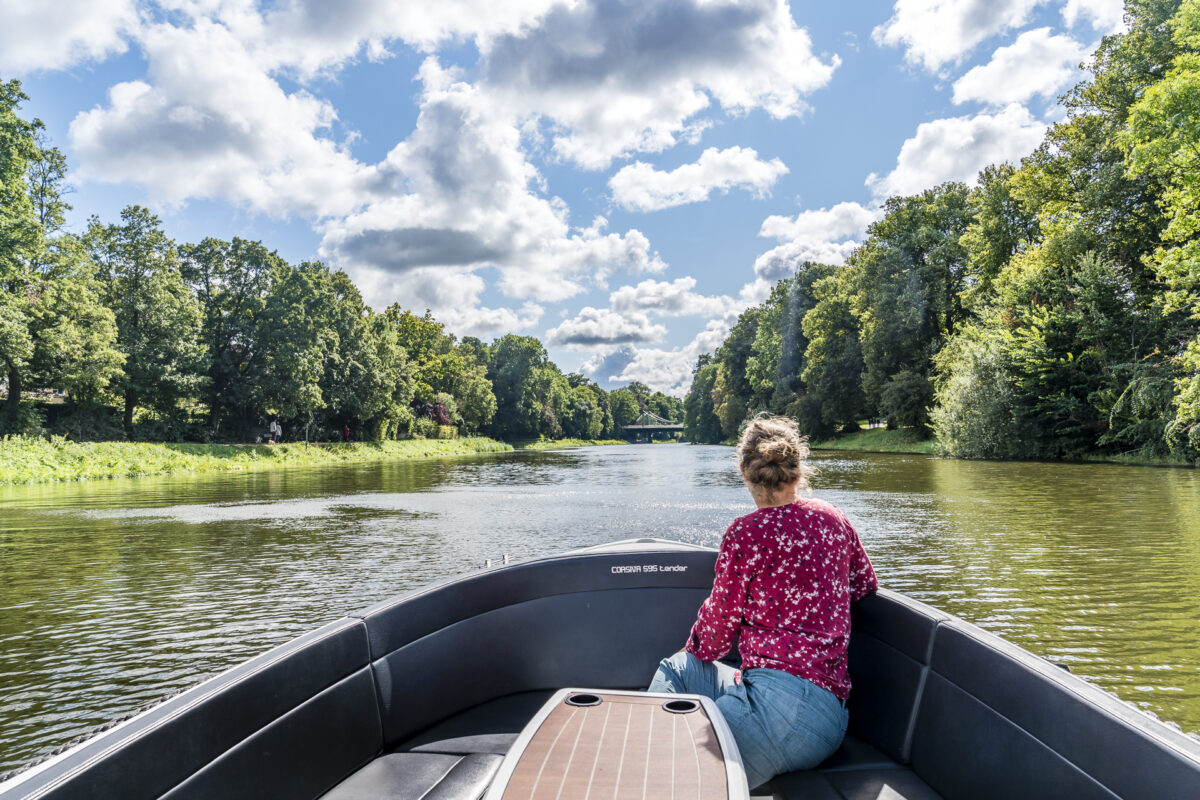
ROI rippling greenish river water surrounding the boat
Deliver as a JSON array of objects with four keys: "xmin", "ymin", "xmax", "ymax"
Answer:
[{"xmin": 0, "ymin": 445, "xmax": 1200, "ymax": 772}]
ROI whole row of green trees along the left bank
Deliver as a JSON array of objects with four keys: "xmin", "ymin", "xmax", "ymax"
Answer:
[{"xmin": 0, "ymin": 80, "xmax": 683, "ymax": 441}]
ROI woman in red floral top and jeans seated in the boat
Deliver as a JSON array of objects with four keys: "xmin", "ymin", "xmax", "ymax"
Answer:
[{"xmin": 649, "ymin": 416, "xmax": 878, "ymax": 789}]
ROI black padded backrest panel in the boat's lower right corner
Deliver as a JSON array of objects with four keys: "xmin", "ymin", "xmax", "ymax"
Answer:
[{"xmin": 912, "ymin": 620, "xmax": 1200, "ymax": 800}]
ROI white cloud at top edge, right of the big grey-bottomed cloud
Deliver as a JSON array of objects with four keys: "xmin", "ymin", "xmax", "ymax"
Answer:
[{"xmin": 871, "ymin": 0, "xmax": 1046, "ymax": 72}]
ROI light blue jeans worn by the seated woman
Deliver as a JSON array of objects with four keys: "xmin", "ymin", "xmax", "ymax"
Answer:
[{"xmin": 649, "ymin": 652, "xmax": 850, "ymax": 789}]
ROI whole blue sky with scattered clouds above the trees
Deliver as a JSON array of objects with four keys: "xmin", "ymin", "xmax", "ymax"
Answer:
[{"xmin": 0, "ymin": 0, "xmax": 1123, "ymax": 396}]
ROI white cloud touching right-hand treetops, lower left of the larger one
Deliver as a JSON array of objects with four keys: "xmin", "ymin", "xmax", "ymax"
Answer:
[{"xmin": 754, "ymin": 203, "xmax": 880, "ymax": 282}]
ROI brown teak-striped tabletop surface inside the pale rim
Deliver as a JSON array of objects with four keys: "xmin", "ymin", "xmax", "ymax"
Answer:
[{"xmin": 503, "ymin": 692, "xmax": 728, "ymax": 800}]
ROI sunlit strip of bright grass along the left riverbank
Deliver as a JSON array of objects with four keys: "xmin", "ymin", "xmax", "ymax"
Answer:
[{"xmin": 0, "ymin": 437, "xmax": 512, "ymax": 486}]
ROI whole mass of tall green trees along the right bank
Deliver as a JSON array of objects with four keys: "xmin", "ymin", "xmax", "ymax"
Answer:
[{"xmin": 684, "ymin": 0, "xmax": 1200, "ymax": 461}]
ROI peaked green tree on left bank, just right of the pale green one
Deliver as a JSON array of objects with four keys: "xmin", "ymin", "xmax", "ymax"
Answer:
[{"xmin": 84, "ymin": 205, "xmax": 203, "ymax": 439}]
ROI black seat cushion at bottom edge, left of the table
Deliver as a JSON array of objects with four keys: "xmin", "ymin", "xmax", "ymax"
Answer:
[{"xmin": 322, "ymin": 753, "xmax": 504, "ymax": 800}]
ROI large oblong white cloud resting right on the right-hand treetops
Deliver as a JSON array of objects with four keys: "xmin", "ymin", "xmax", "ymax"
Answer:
[{"xmin": 866, "ymin": 103, "xmax": 1046, "ymax": 198}]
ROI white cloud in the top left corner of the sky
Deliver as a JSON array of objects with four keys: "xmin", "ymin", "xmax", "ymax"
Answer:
[{"xmin": 0, "ymin": 0, "xmax": 138, "ymax": 77}]
